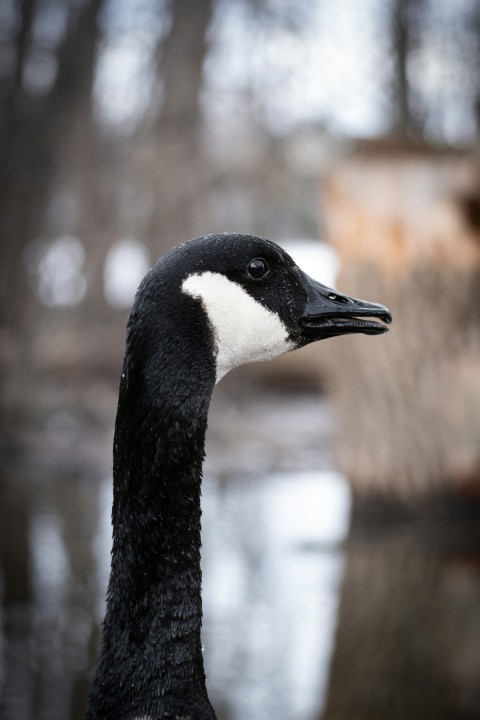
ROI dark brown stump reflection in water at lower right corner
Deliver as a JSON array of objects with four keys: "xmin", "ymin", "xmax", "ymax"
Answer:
[{"xmin": 321, "ymin": 526, "xmax": 480, "ymax": 720}]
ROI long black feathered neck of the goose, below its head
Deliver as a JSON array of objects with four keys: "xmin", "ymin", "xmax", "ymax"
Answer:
[{"xmin": 87, "ymin": 294, "xmax": 215, "ymax": 720}]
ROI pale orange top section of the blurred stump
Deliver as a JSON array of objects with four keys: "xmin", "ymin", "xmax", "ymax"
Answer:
[{"xmin": 323, "ymin": 141, "xmax": 480, "ymax": 274}]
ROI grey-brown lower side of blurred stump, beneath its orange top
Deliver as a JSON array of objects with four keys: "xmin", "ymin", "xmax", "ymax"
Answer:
[{"xmin": 328, "ymin": 264, "xmax": 480, "ymax": 502}]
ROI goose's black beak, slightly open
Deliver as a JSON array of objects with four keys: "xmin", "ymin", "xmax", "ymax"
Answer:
[{"xmin": 300, "ymin": 270, "xmax": 392, "ymax": 342}]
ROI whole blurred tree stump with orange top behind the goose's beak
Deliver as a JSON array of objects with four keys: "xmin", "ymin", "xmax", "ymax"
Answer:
[{"xmin": 323, "ymin": 142, "xmax": 480, "ymax": 512}]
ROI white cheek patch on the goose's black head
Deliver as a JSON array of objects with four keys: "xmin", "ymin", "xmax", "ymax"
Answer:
[{"xmin": 182, "ymin": 272, "xmax": 294, "ymax": 382}]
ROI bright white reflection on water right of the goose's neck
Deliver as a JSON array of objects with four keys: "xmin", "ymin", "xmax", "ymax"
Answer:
[{"xmin": 203, "ymin": 472, "xmax": 350, "ymax": 720}]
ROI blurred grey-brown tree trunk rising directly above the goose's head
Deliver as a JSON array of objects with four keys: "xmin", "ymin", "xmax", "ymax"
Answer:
[{"xmin": 147, "ymin": 0, "xmax": 213, "ymax": 257}]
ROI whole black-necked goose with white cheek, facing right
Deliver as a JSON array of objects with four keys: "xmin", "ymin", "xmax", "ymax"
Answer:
[{"xmin": 86, "ymin": 234, "xmax": 391, "ymax": 720}]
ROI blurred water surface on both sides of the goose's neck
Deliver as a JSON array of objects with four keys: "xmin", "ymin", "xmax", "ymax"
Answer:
[{"xmin": 0, "ymin": 397, "xmax": 480, "ymax": 720}]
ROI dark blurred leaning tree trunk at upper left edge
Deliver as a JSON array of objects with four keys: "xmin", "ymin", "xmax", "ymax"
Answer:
[{"xmin": 0, "ymin": 0, "xmax": 104, "ymax": 414}]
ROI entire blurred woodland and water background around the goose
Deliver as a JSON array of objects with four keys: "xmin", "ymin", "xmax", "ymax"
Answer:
[{"xmin": 0, "ymin": 0, "xmax": 480, "ymax": 720}]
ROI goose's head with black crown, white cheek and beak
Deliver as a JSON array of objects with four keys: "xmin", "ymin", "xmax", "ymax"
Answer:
[{"xmin": 137, "ymin": 234, "xmax": 391, "ymax": 382}]
